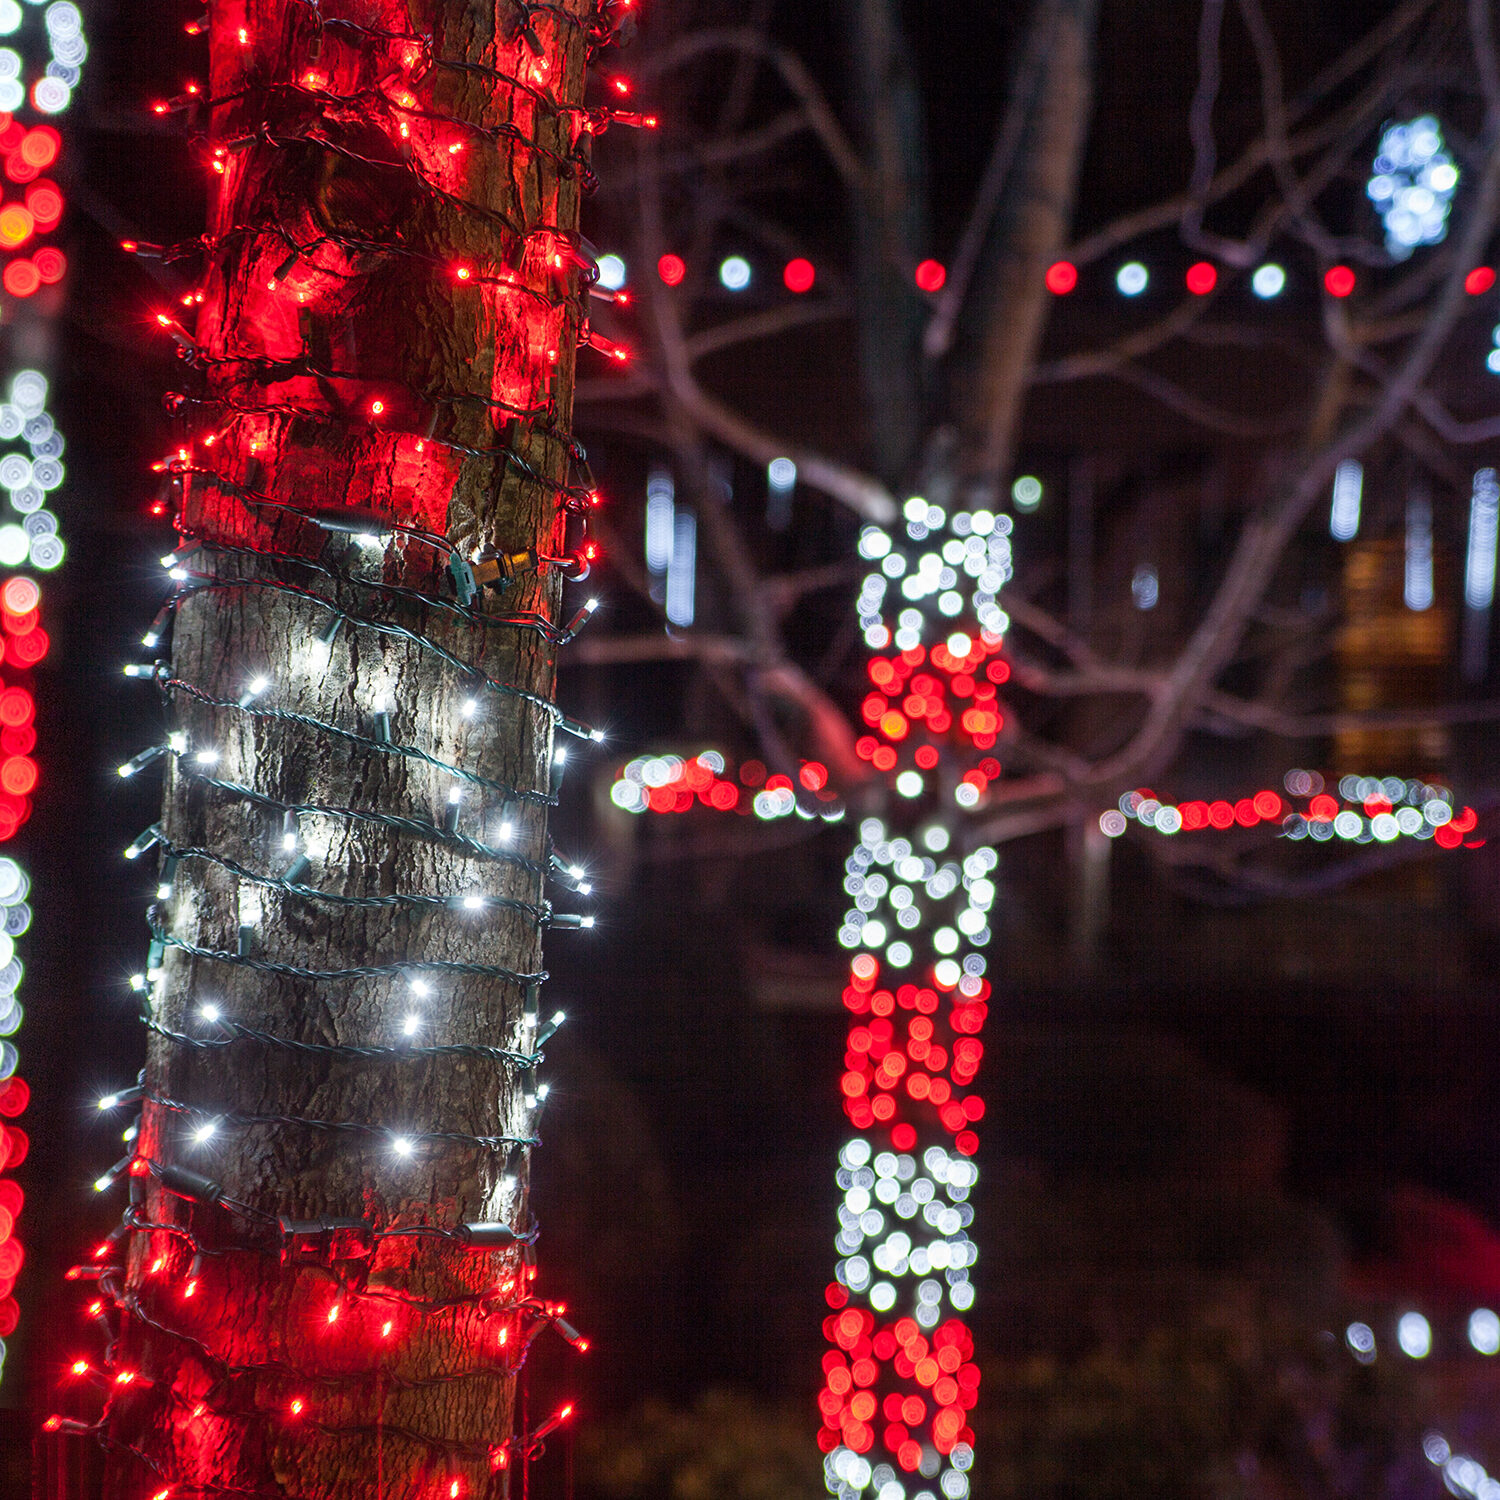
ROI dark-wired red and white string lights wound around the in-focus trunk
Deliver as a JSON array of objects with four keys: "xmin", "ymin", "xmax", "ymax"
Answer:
[{"xmin": 47, "ymin": 0, "xmax": 654, "ymax": 1500}]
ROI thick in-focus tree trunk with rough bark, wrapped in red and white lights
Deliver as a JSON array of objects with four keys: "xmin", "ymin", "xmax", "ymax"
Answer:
[{"xmin": 95, "ymin": 0, "xmax": 593, "ymax": 1500}]
